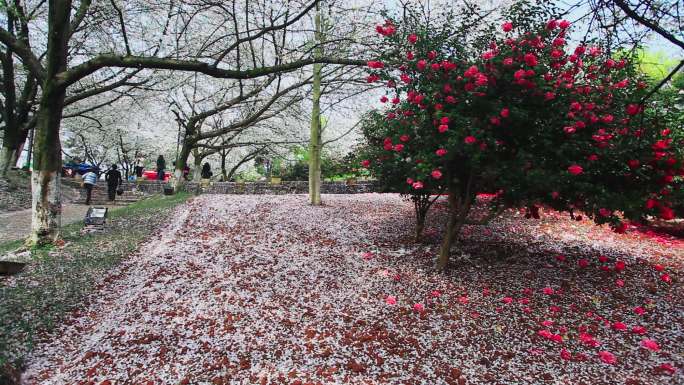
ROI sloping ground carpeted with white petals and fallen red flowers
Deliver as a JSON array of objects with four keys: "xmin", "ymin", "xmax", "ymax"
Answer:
[{"xmin": 24, "ymin": 194, "xmax": 684, "ymax": 385}]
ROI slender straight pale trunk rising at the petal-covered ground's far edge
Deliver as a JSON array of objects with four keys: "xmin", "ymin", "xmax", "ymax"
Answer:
[{"xmin": 309, "ymin": 3, "xmax": 323, "ymax": 206}]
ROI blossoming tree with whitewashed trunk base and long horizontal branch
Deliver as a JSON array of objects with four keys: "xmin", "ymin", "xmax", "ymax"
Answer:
[{"xmin": 0, "ymin": 0, "xmax": 362, "ymax": 244}]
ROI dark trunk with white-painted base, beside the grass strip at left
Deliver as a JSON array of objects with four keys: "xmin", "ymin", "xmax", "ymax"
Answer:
[{"xmin": 27, "ymin": 0, "xmax": 71, "ymax": 245}]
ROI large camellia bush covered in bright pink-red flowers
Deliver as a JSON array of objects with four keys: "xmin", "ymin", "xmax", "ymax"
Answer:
[{"xmin": 366, "ymin": 2, "xmax": 682, "ymax": 269}]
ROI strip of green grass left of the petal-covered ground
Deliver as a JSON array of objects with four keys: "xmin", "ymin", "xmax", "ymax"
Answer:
[{"xmin": 0, "ymin": 193, "xmax": 191, "ymax": 376}]
